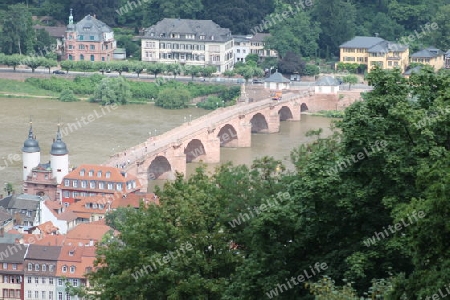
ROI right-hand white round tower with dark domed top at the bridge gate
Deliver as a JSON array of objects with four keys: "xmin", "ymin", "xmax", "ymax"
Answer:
[{"xmin": 50, "ymin": 124, "xmax": 69, "ymax": 184}]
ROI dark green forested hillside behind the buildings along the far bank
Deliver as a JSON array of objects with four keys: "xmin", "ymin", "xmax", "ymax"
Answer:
[{"xmin": 0, "ymin": 0, "xmax": 450, "ymax": 58}]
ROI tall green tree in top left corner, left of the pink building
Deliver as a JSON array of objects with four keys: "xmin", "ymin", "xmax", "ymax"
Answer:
[{"xmin": 1, "ymin": 4, "xmax": 35, "ymax": 54}]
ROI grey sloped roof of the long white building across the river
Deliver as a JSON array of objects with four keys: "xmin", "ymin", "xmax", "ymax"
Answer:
[{"xmin": 144, "ymin": 18, "xmax": 232, "ymax": 42}]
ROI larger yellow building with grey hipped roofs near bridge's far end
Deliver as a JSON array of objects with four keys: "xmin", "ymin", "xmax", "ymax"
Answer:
[{"xmin": 339, "ymin": 36, "xmax": 409, "ymax": 73}]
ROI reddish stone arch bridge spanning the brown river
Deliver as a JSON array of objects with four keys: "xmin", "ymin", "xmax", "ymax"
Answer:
[{"xmin": 106, "ymin": 90, "xmax": 338, "ymax": 191}]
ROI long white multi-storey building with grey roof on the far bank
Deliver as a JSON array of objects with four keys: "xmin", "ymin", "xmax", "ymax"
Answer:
[{"xmin": 141, "ymin": 18, "xmax": 234, "ymax": 73}]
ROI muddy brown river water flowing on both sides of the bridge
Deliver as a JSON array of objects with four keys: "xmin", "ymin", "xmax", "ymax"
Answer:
[{"xmin": 0, "ymin": 98, "xmax": 331, "ymax": 192}]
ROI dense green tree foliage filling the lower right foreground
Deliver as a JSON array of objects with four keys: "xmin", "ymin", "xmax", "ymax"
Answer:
[{"xmin": 82, "ymin": 68, "xmax": 450, "ymax": 300}]
